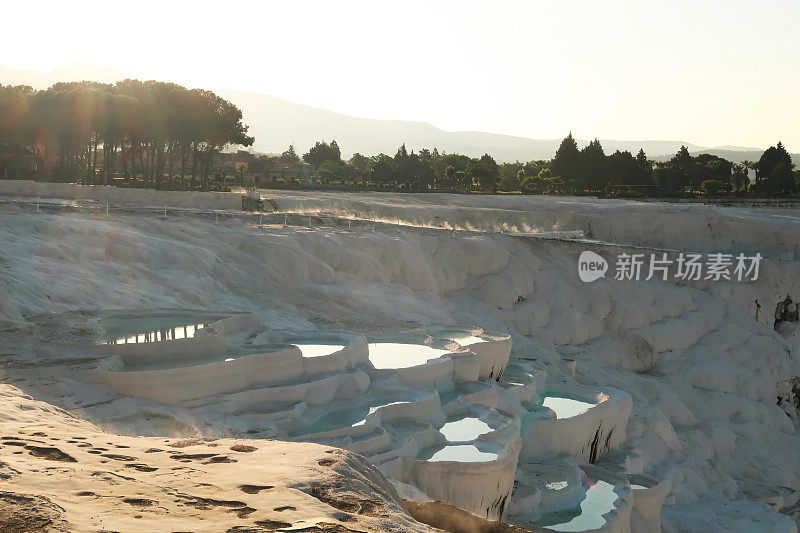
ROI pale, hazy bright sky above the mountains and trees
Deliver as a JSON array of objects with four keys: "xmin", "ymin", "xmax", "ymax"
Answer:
[{"xmin": 0, "ymin": 0, "xmax": 800, "ymax": 152}]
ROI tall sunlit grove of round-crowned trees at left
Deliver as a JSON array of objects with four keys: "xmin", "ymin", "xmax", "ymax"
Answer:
[{"xmin": 0, "ymin": 79, "xmax": 254, "ymax": 188}]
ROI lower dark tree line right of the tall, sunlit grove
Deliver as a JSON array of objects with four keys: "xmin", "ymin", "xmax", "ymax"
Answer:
[{"xmin": 290, "ymin": 133, "xmax": 800, "ymax": 195}]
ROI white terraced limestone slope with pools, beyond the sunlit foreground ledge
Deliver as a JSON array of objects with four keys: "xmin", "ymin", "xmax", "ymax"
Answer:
[{"xmin": 0, "ymin": 183, "xmax": 800, "ymax": 532}]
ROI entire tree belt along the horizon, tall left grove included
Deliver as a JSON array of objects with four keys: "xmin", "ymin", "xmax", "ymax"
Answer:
[{"xmin": 0, "ymin": 79, "xmax": 798, "ymax": 195}]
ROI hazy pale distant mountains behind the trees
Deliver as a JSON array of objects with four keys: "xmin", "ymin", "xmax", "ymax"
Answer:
[{"xmin": 0, "ymin": 64, "xmax": 800, "ymax": 163}]
